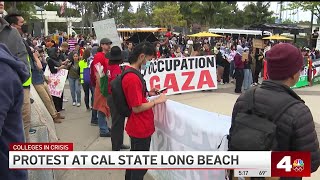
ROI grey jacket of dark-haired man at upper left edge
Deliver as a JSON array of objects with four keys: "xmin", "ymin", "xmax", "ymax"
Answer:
[{"xmin": 0, "ymin": 17, "xmax": 30, "ymax": 76}]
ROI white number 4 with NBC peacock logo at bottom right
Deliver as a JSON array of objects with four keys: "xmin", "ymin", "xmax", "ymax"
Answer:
[{"xmin": 277, "ymin": 156, "xmax": 304, "ymax": 172}]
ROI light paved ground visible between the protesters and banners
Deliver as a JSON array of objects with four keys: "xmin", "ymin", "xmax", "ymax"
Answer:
[{"xmin": 56, "ymin": 84, "xmax": 320, "ymax": 180}]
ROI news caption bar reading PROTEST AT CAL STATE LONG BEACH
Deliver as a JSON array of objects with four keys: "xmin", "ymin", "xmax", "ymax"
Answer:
[{"xmin": 9, "ymin": 143, "xmax": 311, "ymax": 177}]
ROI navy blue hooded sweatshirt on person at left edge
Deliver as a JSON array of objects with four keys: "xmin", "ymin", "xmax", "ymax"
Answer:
[{"xmin": 0, "ymin": 43, "xmax": 29, "ymax": 180}]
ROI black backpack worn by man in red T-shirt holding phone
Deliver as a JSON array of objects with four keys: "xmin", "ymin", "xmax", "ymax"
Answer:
[{"xmin": 111, "ymin": 68, "xmax": 147, "ymax": 117}]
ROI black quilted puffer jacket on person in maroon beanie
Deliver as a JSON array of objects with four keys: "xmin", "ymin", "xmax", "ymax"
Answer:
[{"xmin": 231, "ymin": 80, "xmax": 320, "ymax": 176}]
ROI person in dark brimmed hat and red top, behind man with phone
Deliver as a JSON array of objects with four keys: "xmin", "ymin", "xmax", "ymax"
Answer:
[{"xmin": 106, "ymin": 46, "xmax": 130, "ymax": 151}]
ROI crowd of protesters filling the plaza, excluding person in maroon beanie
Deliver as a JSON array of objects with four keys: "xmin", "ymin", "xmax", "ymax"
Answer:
[{"xmin": 0, "ymin": 0, "xmax": 320, "ymax": 176}]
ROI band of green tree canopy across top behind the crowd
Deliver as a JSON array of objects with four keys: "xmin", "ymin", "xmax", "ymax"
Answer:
[{"xmin": 10, "ymin": 1, "xmax": 278, "ymax": 33}]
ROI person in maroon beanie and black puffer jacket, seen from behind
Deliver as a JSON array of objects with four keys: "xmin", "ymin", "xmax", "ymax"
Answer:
[{"xmin": 232, "ymin": 43, "xmax": 320, "ymax": 180}]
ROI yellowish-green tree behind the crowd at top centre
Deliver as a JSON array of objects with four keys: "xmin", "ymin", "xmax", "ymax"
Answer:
[{"xmin": 153, "ymin": 3, "xmax": 186, "ymax": 28}]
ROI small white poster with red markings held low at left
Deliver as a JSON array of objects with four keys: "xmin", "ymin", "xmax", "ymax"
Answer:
[{"xmin": 44, "ymin": 66, "xmax": 68, "ymax": 97}]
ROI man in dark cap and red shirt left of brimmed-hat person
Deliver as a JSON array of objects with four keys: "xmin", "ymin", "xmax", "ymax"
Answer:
[{"xmin": 90, "ymin": 38, "xmax": 112, "ymax": 137}]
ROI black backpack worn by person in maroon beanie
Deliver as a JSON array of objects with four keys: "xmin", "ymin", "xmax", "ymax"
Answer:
[{"xmin": 228, "ymin": 87, "xmax": 301, "ymax": 151}]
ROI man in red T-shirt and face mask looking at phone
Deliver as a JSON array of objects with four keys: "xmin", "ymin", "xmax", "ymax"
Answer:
[{"xmin": 122, "ymin": 42, "xmax": 167, "ymax": 180}]
